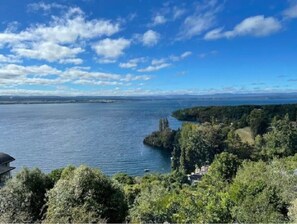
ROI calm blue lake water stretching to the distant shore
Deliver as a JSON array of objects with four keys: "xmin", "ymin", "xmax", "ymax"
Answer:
[{"xmin": 0, "ymin": 99, "xmax": 297, "ymax": 175}]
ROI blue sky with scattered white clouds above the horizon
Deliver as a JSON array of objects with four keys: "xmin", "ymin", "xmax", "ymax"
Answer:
[{"xmin": 0, "ymin": 0, "xmax": 297, "ymax": 96}]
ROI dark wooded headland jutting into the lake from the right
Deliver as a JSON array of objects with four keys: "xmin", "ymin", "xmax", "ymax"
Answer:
[{"xmin": 173, "ymin": 104, "xmax": 297, "ymax": 123}]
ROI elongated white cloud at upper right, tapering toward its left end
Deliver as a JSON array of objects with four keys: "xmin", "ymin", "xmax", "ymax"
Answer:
[{"xmin": 204, "ymin": 15, "xmax": 282, "ymax": 40}]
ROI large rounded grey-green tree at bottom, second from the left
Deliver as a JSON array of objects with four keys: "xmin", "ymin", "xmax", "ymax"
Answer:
[{"xmin": 46, "ymin": 166, "xmax": 127, "ymax": 223}]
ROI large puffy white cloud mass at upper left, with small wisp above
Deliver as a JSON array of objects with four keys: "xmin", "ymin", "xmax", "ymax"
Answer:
[{"xmin": 0, "ymin": 6, "xmax": 120, "ymax": 64}]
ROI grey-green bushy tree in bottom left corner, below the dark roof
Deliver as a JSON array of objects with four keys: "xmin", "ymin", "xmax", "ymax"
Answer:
[{"xmin": 0, "ymin": 168, "xmax": 53, "ymax": 223}]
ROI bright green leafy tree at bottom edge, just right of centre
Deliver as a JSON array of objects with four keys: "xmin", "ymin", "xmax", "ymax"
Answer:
[{"xmin": 172, "ymin": 175, "xmax": 232, "ymax": 223}]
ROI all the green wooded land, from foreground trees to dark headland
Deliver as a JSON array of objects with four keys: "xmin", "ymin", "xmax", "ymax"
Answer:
[{"xmin": 0, "ymin": 104, "xmax": 297, "ymax": 223}]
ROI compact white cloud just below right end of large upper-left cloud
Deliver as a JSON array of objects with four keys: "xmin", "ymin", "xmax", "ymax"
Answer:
[{"xmin": 92, "ymin": 38, "xmax": 131, "ymax": 59}]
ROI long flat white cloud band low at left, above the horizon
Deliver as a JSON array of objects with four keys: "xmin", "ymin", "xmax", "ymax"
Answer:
[{"xmin": 0, "ymin": 64, "xmax": 151, "ymax": 87}]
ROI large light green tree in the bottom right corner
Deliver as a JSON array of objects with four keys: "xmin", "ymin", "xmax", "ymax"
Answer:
[{"xmin": 229, "ymin": 160, "xmax": 297, "ymax": 223}]
